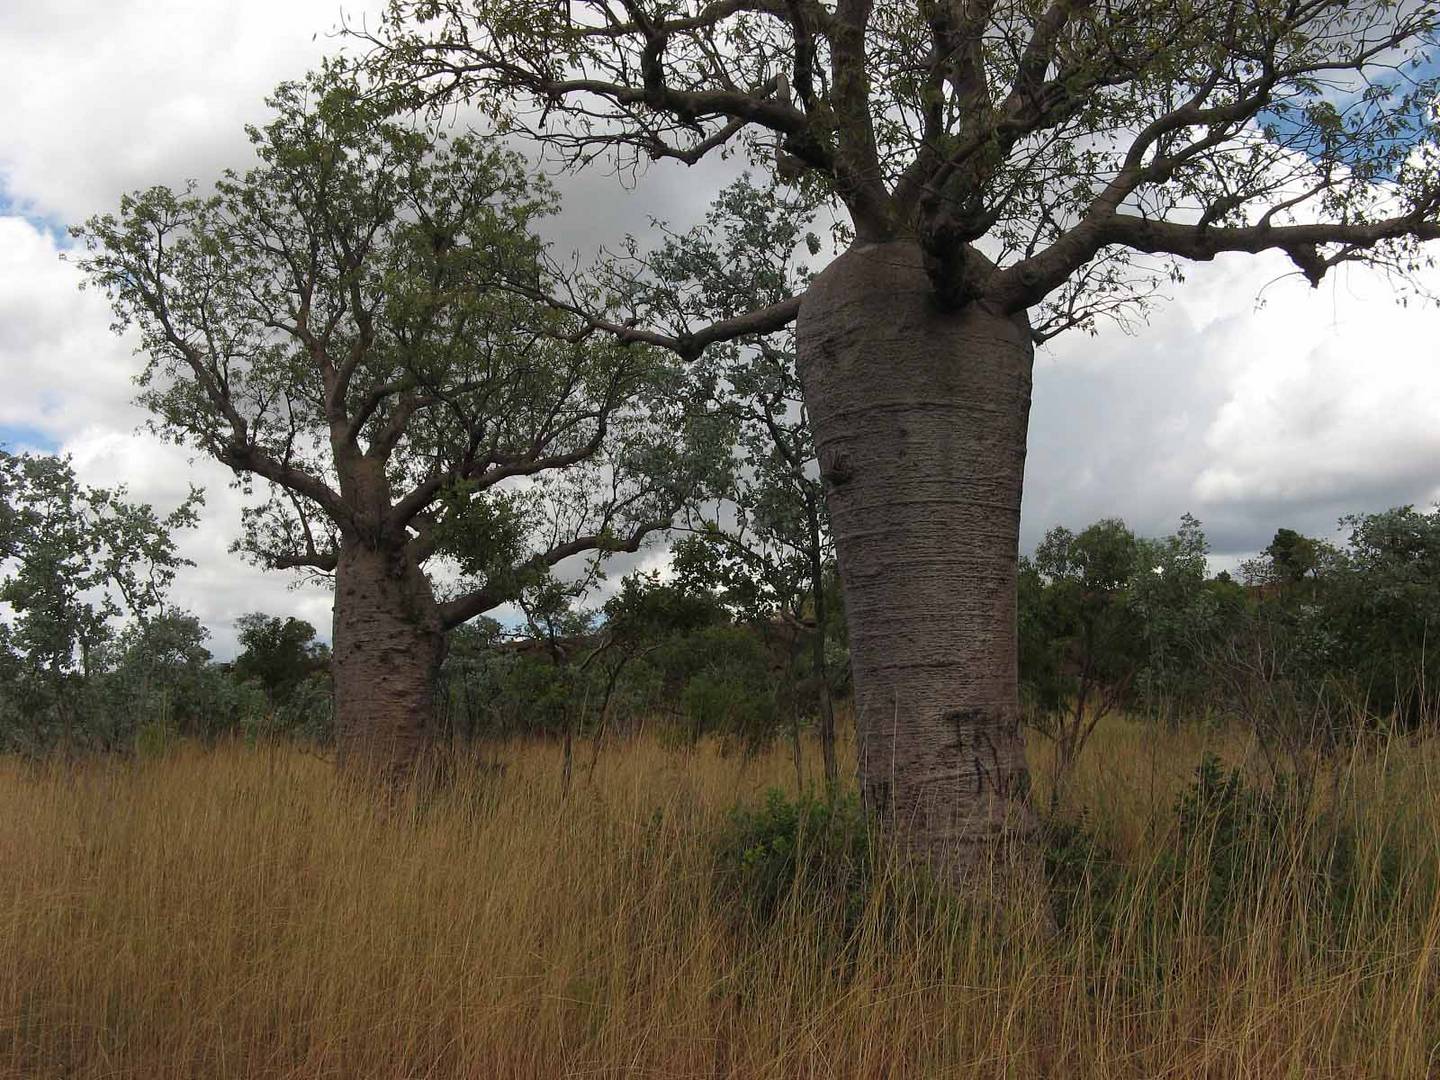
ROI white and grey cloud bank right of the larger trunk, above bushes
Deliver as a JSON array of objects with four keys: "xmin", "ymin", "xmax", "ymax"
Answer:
[{"xmin": 1025, "ymin": 256, "xmax": 1440, "ymax": 553}]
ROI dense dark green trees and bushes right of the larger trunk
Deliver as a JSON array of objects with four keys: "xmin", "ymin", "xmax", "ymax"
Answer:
[{"xmin": 1018, "ymin": 507, "xmax": 1440, "ymax": 748}]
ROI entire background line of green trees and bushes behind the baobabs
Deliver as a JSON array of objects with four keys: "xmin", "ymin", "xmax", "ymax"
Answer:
[{"xmin": 0, "ymin": 443, "xmax": 1440, "ymax": 792}]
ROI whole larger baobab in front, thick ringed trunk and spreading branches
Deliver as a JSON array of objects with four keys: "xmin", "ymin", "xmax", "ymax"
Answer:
[{"xmin": 362, "ymin": 0, "xmax": 1440, "ymax": 870}]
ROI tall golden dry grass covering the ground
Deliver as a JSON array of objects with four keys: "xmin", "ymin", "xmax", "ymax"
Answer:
[{"xmin": 0, "ymin": 720, "xmax": 1440, "ymax": 1080}]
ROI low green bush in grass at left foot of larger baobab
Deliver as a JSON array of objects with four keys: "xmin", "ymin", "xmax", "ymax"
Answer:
[{"xmin": 714, "ymin": 789, "xmax": 877, "ymax": 935}]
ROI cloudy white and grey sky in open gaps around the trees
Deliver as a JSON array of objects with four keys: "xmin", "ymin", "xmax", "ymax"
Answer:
[{"xmin": 0, "ymin": 0, "xmax": 1440, "ymax": 657}]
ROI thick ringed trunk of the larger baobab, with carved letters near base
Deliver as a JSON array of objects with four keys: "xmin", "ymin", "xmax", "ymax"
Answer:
[{"xmin": 798, "ymin": 242, "xmax": 1034, "ymax": 880}]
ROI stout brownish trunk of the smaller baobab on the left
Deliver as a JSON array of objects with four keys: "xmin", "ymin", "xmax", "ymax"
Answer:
[{"xmin": 333, "ymin": 544, "xmax": 445, "ymax": 782}]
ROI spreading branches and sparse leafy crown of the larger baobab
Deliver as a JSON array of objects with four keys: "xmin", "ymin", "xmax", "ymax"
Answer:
[{"xmin": 367, "ymin": 0, "xmax": 1440, "ymax": 332}]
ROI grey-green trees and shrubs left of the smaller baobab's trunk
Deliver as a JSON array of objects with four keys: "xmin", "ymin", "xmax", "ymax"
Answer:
[{"xmin": 0, "ymin": 463, "xmax": 328, "ymax": 755}]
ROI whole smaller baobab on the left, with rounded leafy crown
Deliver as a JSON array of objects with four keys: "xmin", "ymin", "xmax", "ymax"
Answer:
[{"xmin": 76, "ymin": 65, "xmax": 714, "ymax": 778}]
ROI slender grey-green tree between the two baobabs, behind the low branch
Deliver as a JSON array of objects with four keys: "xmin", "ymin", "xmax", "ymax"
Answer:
[{"xmin": 665, "ymin": 177, "xmax": 840, "ymax": 785}]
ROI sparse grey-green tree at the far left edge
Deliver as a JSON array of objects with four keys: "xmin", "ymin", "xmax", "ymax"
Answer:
[{"xmin": 0, "ymin": 451, "xmax": 202, "ymax": 750}]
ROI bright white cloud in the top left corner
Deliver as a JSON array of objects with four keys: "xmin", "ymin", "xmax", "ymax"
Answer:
[{"xmin": 0, "ymin": 0, "xmax": 380, "ymax": 223}]
